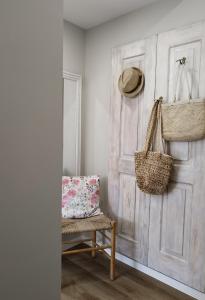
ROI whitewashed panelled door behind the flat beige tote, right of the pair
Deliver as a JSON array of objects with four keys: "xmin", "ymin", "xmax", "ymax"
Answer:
[{"xmin": 148, "ymin": 22, "xmax": 205, "ymax": 292}]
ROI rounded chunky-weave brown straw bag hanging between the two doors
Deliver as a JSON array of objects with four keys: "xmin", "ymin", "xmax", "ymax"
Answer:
[{"xmin": 135, "ymin": 99, "xmax": 173, "ymax": 195}]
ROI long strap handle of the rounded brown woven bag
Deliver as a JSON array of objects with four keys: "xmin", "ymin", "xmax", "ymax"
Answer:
[{"xmin": 144, "ymin": 97, "xmax": 162, "ymax": 155}]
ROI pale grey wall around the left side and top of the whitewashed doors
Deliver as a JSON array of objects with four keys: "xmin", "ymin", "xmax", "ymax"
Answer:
[{"xmin": 83, "ymin": 0, "xmax": 205, "ymax": 211}]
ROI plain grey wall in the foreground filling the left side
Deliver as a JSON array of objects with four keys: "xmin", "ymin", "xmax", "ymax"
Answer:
[{"xmin": 0, "ymin": 0, "xmax": 63, "ymax": 300}]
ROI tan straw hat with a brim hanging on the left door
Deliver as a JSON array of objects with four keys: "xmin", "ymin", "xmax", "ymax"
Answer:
[{"xmin": 118, "ymin": 67, "xmax": 145, "ymax": 98}]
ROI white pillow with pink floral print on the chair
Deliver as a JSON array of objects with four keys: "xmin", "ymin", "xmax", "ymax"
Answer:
[{"xmin": 62, "ymin": 175, "xmax": 101, "ymax": 218}]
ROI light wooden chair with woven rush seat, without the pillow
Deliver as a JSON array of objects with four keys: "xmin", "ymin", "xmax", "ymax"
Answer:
[{"xmin": 62, "ymin": 215, "xmax": 116, "ymax": 280}]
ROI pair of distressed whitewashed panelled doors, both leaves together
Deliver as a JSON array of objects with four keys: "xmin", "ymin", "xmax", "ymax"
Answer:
[{"xmin": 108, "ymin": 22, "xmax": 205, "ymax": 292}]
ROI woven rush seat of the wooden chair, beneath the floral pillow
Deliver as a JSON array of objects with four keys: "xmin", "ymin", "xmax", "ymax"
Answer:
[{"xmin": 62, "ymin": 214, "xmax": 112, "ymax": 234}]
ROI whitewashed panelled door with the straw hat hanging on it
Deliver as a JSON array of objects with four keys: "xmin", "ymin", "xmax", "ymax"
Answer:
[{"xmin": 109, "ymin": 36, "xmax": 156, "ymax": 265}]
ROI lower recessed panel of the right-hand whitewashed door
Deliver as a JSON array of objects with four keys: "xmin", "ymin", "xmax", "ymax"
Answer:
[{"xmin": 160, "ymin": 183, "xmax": 192, "ymax": 262}]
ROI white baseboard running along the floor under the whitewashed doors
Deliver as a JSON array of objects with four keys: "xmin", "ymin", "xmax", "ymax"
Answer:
[{"xmin": 103, "ymin": 250, "xmax": 205, "ymax": 300}]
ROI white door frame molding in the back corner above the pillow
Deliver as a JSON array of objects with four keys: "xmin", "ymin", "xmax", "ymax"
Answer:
[{"xmin": 63, "ymin": 71, "xmax": 82, "ymax": 175}]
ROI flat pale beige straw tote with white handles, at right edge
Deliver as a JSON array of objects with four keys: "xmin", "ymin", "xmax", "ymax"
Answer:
[{"xmin": 162, "ymin": 65, "xmax": 205, "ymax": 141}]
